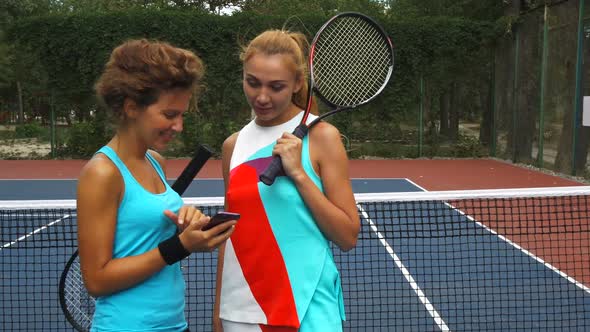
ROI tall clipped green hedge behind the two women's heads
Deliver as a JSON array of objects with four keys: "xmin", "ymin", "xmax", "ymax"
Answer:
[{"xmin": 7, "ymin": 10, "xmax": 498, "ymax": 159}]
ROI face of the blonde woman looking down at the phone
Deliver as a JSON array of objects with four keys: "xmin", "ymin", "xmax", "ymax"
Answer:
[{"xmin": 243, "ymin": 53, "xmax": 302, "ymax": 126}]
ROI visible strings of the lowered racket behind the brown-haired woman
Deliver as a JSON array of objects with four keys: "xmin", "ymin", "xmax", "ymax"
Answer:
[{"xmin": 64, "ymin": 260, "xmax": 94, "ymax": 327}]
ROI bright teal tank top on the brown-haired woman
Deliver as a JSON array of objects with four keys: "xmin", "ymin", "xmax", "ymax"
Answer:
[{"xmin": 91, "ymin": 146, "xmax": 187, "ymax": 332}]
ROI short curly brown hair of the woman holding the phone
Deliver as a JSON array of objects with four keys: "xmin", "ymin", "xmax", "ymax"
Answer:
[{"xmin": 94, "ymin": 39, "xmax": 205, "ymax": 118}]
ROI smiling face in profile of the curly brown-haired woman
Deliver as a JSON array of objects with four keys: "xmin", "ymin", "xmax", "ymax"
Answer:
[{"xmin": 135, "ymin": 89, "xmax": 192, "ymax": 150}]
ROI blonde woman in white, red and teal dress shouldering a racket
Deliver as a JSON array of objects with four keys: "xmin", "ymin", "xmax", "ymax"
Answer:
[{"xmin": 213, "ymin": 30, "xmax": 360, "ymax": 332}]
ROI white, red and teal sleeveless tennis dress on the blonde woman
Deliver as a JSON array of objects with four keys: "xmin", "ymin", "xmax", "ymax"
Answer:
[{"xmin": 220, "ymin": 112, "xmax": 345, "ymax": 332}]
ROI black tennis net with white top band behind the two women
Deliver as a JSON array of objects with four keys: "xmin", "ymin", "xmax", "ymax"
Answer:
[{"xmin": 0, "ymin": 187, "xmax": 590, "ymax": 331}]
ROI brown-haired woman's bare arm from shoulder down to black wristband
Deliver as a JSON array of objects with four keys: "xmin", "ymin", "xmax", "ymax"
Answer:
[{"xmin": 77, "ymin": 156, "xmax": 166, "ymax": 296}]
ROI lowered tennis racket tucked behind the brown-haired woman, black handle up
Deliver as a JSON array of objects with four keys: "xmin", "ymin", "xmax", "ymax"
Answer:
[{"xmin": 59, "ymin": 145, "xmax": 213, "ymax": 332}]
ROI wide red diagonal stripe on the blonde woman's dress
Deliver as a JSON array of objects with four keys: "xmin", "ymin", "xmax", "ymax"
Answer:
[{"xmin": 227, "ymin": 164, "xmax": 299, "ymax": 328}]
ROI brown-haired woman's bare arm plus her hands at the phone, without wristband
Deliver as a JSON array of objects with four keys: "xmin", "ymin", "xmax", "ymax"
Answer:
[{"xmin": 77, "ymin": 156, "xmax": 235, "ymax": 296}]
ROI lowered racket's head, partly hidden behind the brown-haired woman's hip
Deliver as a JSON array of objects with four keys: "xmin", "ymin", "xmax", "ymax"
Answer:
[{"xmin": 59, "ymin": 250, "xmax": 95, "ymax": 332}]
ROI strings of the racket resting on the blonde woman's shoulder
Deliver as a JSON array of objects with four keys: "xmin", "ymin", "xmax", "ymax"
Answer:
[{"xmin": 312, "ymin": 17, "xmax": 392, "ymax": 106}]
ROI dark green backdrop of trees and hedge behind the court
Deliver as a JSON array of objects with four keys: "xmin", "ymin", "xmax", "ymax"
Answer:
[{"xmin": 0, "ymin": 0, "xmax": 590, "ymax": 176}]
